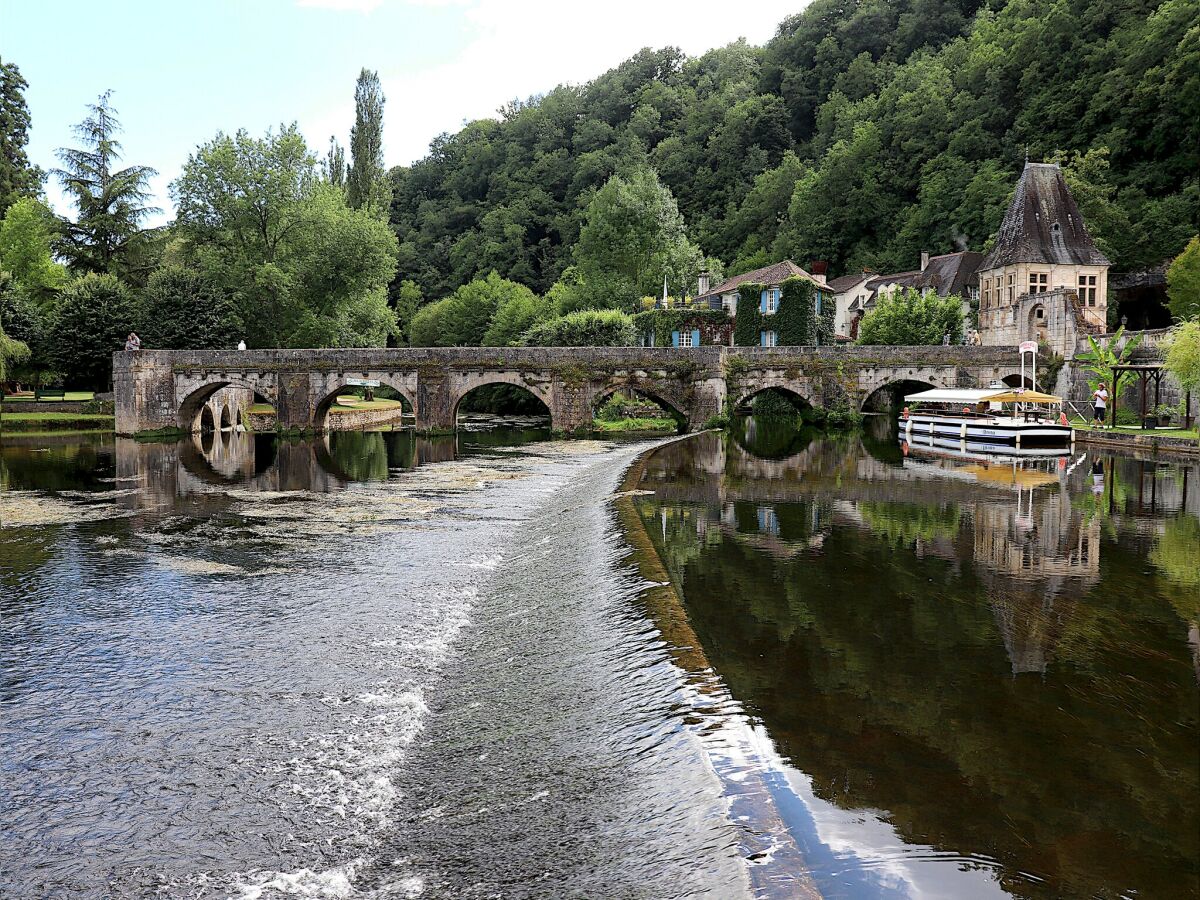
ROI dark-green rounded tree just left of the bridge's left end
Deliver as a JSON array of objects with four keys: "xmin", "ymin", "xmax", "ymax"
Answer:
[{"xmin": 50, "ymin": 272, "xmax": 138, "ymax": 390}]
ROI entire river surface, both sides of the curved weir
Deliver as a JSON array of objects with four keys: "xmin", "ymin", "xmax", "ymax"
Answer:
[{"xmin": 0, "ymin": 420, "xmax": 1200, "ymax": 898}]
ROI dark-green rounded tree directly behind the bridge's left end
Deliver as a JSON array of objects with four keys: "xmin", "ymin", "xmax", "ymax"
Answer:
[{"xmin": 138, "ymin": 265, "xmax": 242, "ymax": 350}]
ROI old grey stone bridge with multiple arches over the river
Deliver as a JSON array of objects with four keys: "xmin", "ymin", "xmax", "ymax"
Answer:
[{"xmin": 113, "ymin": 347, "xmax": 1020, "ymax": 434}]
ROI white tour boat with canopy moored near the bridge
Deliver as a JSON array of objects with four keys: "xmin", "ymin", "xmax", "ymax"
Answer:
[{"xmin": 900, "ymin": 386, "xmax": 1074, "ymax": 456}]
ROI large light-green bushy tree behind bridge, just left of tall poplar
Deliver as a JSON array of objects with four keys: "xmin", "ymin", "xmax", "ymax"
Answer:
[{"xmin": 172, "ymin": 125, "xmax": 397, "ymax": 347}]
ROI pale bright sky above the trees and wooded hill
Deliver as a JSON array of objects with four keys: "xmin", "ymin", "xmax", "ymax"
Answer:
[{"xmin": 0, "ymin": 0, "xmax": 805, "ymax": 223}]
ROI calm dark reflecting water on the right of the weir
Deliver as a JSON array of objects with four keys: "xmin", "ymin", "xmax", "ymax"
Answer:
[{"xmin": 632, "ymin": 420, "xmax": 1200, "ymax": 898}]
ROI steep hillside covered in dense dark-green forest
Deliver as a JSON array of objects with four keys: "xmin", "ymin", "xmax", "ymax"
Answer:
[{"xmin": 390, "ymin": 0, "xmax": 1200, "ymax": 296}]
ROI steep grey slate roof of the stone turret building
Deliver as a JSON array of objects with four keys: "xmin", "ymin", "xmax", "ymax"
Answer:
[{"xmin": 979, "ymin": 162, "xmax": 1110, "ymax": 271}]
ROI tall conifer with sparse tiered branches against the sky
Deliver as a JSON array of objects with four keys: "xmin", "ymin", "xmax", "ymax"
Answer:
[{"xmin": 54, "ymin": 91, "xmax": 160, "ymax": 275}]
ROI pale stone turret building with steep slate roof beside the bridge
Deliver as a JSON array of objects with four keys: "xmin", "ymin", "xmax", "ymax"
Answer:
[{"xmin": 978, "ymin": 162, "xmax": 1109, "ymax": 356}]
